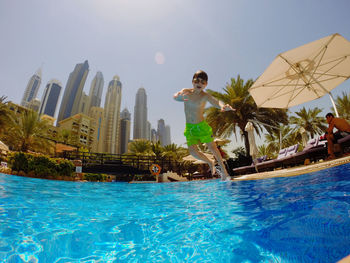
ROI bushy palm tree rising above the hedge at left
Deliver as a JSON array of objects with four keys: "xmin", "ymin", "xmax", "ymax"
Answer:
[{"xmin": 5, "ymin": 110, "xmax": 54, "ymax": 153}]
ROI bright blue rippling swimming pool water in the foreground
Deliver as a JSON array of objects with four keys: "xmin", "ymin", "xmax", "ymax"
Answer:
[{"xmin": 0, "ymin": 164, "xmax": 350, "ymax": 263}]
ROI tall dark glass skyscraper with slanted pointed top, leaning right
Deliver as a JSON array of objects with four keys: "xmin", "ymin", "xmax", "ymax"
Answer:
[{"xmin": 57, "ymin": 60, "xmax": 89, "ymax": 123}]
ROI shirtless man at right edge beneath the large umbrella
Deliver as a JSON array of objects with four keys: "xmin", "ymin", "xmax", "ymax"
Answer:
[{"xmin": 326, "ymin": 113, "xmax": 350, "ymax": 160}]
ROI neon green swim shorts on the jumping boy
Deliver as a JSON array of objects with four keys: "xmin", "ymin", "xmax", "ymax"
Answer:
[{"xmin": 184, "ymin": 121, "xmax": 214, "ymax": 146}]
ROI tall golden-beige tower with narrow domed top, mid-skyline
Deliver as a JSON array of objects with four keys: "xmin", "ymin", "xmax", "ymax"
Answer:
[{"xmin": 104, "ymin": 76, "xmax": 122, "ymax": 154}]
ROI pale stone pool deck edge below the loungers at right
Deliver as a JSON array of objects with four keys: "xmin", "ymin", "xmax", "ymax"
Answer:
[{"xmin": 232, "ymin": 155, "xmax": 350, "ymax": 181}]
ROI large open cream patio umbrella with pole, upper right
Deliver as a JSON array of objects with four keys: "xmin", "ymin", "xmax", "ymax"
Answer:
[{"xmin": 249, "ymin": 34, "xmax": 350, "ymax": 116}]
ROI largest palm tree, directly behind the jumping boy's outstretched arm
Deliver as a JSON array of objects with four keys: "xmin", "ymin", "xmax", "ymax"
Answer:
[{"xmin": 205, "ymin": 75, "xmax": 288, "ymax": 155}]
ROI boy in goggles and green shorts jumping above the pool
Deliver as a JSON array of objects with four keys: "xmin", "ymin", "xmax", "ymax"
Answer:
[{"xmin": 174, "ymin": 70, "xmax": 235, "ymax": 180}]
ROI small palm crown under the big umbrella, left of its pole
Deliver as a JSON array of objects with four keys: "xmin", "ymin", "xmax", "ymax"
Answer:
[{"xmin": 289, "ymin": 107, "xmax": 327, "ymax": 141}]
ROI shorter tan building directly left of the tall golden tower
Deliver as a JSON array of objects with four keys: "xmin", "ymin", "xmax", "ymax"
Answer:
[{"xmin": 89, "ymin": 107, "xmax": 105, "ymax": 153}]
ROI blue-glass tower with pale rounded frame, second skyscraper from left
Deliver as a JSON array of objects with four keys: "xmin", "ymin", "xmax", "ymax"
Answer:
[{"xmin": 39, "ymin": 79, "xmax": 62, "ymax": 117}]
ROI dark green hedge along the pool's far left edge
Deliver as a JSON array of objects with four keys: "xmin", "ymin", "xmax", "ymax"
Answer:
[{"xmin": 8, "ymin": 152, "xmax": 74, "ymax": 177}]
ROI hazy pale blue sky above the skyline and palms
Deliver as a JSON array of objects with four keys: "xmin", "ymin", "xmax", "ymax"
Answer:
[{"xmin": 0, "ymin": 0, "xmax": 350, "ymax": 152}]
